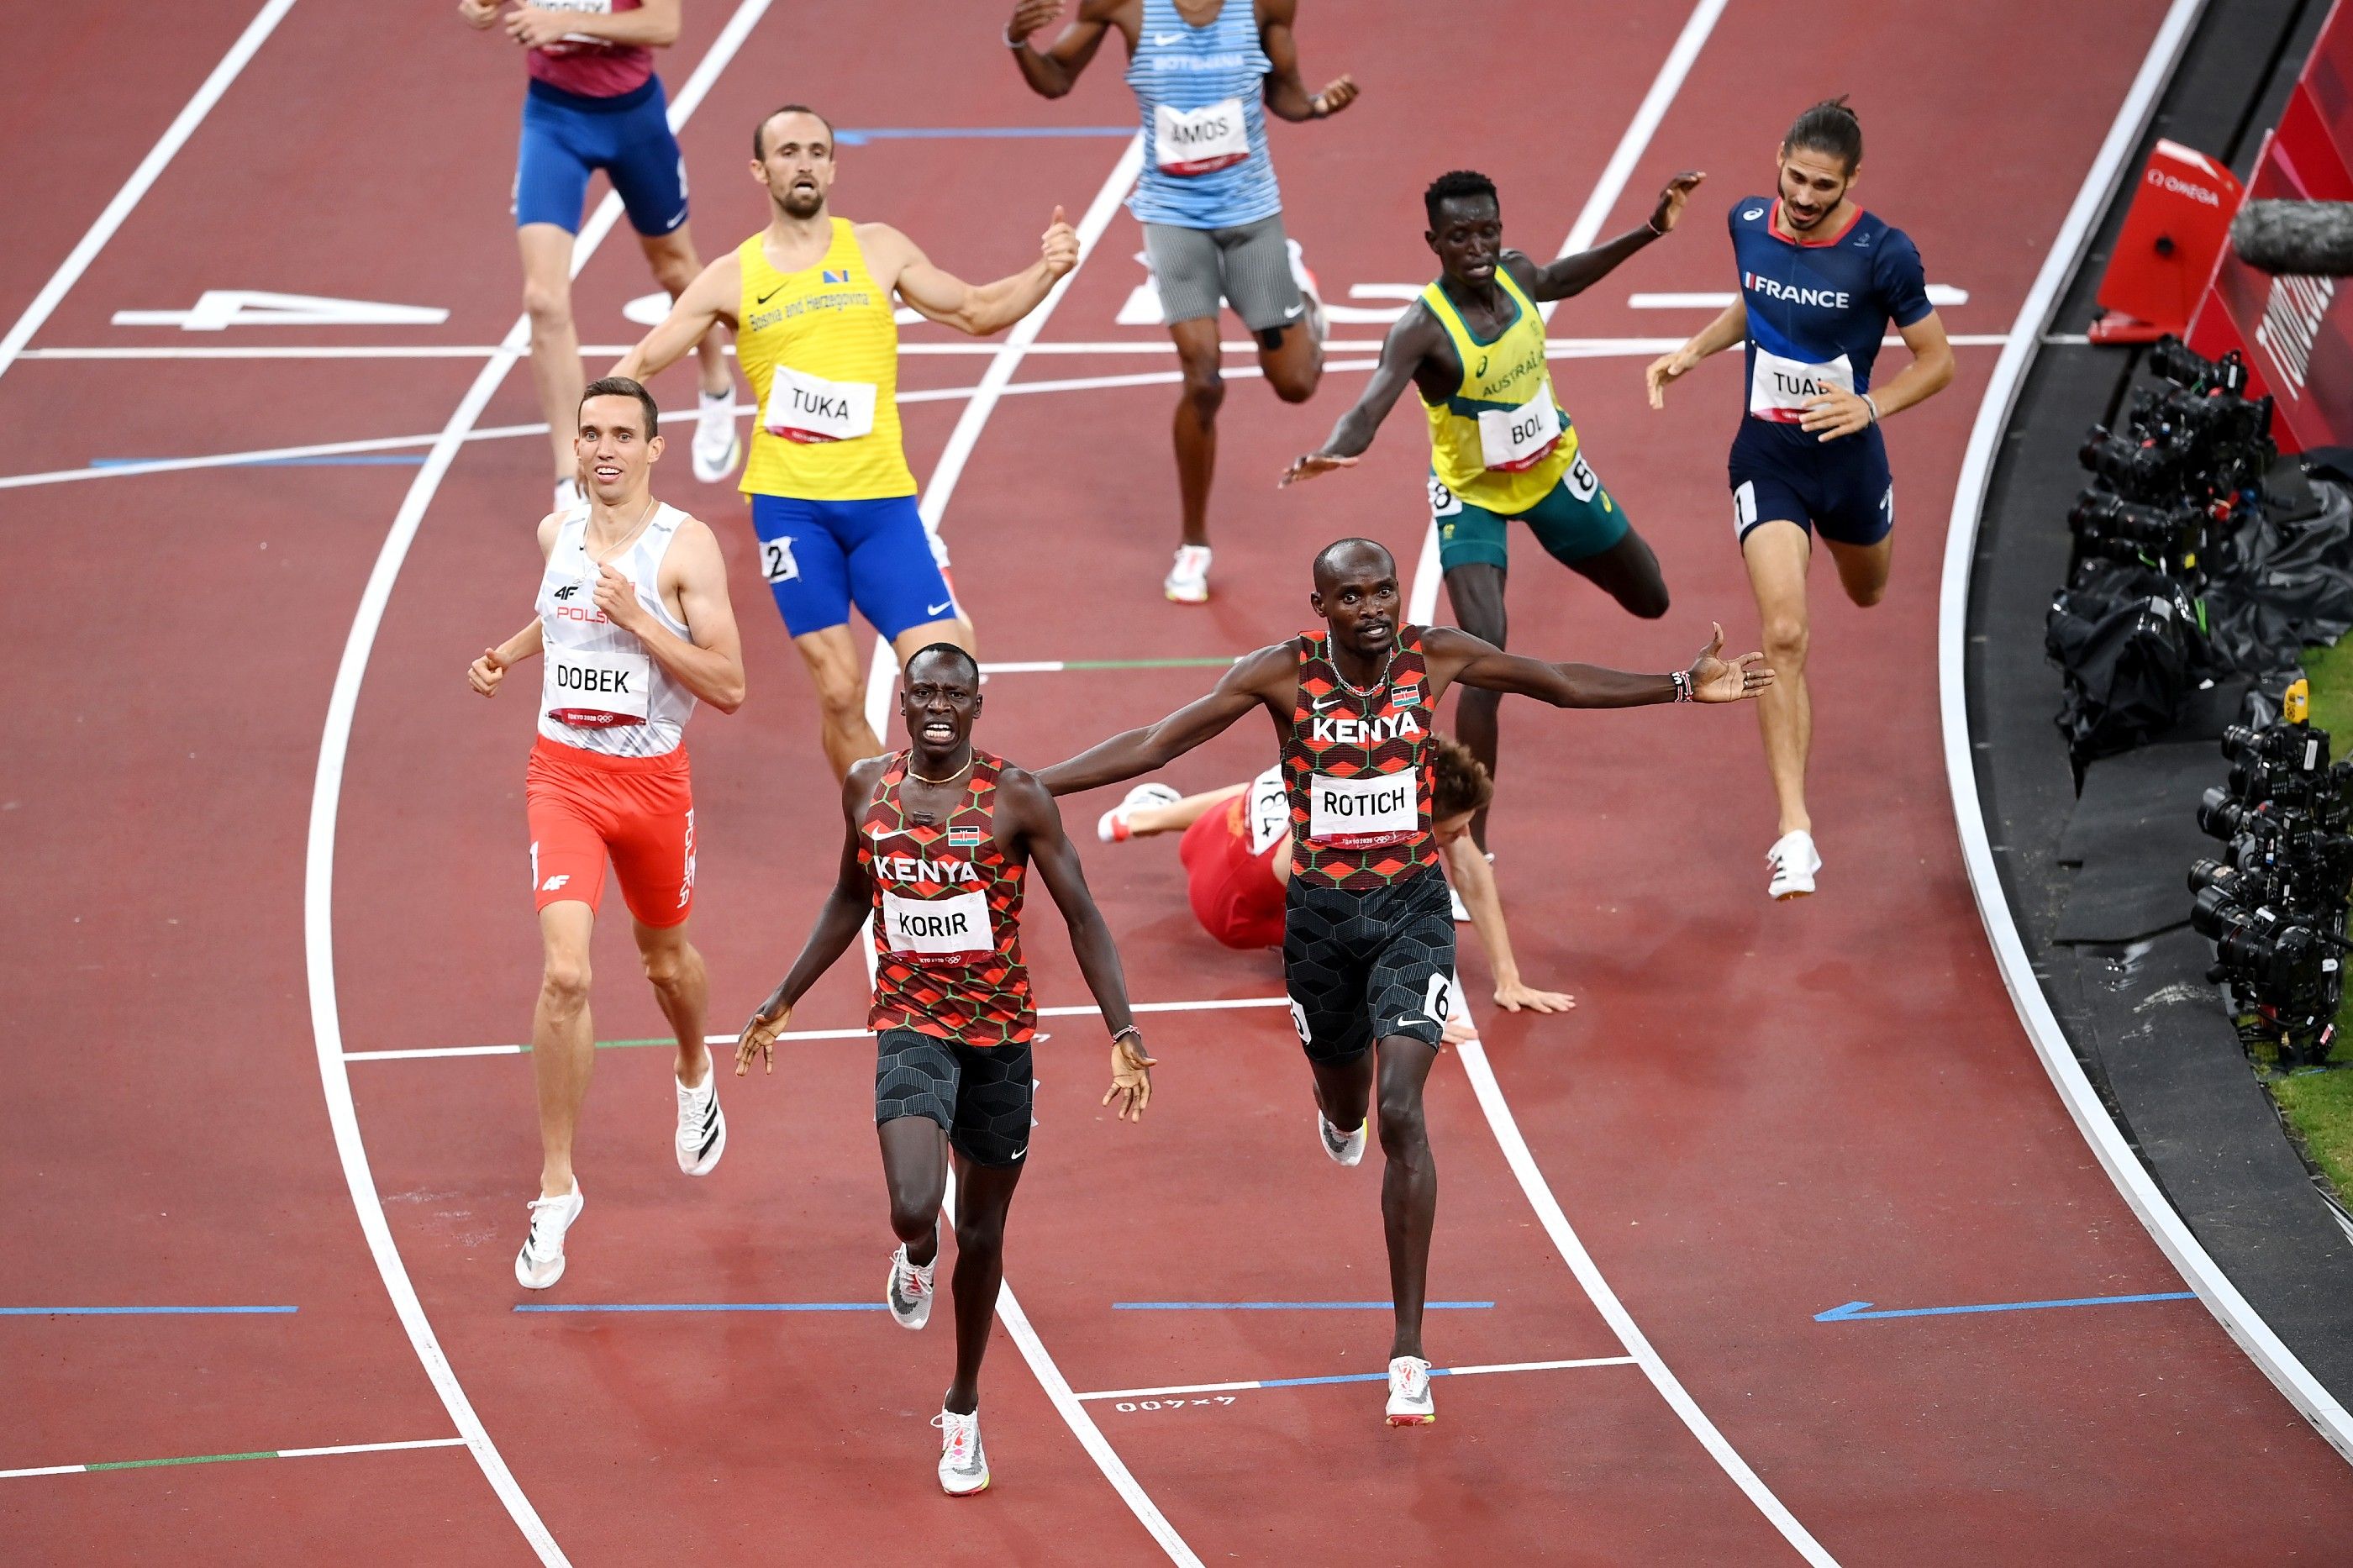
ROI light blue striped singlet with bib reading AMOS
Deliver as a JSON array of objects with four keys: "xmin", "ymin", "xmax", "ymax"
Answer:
[{"xmin": 1127, "ymin": 0, "xmax": 1282, "ymax": 229}]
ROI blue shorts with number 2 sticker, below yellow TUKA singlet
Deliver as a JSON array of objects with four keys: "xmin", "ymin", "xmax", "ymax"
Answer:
[{"xmin": 750, "ymin": 494, "xmax": 955, "ymax": 640}]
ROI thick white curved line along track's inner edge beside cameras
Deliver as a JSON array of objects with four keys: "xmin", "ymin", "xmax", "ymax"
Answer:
[{"xmin": 1936, "ymin": 0, "xmax": 2353, "ymax": 1460}]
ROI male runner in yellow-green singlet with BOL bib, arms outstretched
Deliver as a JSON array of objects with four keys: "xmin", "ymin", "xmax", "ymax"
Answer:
[{"xmin": 1282, "ymin": 170, "xmax": 1701, "ymax": 847}]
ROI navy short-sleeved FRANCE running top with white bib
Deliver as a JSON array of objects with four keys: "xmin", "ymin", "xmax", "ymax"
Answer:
[{"xmin": 1729, "ymin": 196, "xmax": 1935, "ymax": 445}]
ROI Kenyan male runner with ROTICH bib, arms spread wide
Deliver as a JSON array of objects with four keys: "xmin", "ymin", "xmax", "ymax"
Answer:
[{"xmin": 1038, "ymin": 539, "xmax": 1771, "ymax": 1427}]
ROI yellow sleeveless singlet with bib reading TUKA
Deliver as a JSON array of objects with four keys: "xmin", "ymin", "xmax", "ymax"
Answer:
[{"xmin": 736, "ymin": 219, "xmax": 915, "ymax": 502}]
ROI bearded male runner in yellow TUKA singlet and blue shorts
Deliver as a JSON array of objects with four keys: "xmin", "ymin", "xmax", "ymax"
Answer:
[{"xmin": 614, "ymin": 103, "xmax": 1077, "ymax": 777}]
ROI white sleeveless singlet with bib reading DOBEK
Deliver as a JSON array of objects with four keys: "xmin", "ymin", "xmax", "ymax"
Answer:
[{"xmin": 539, "ymin": 502, "xmax": 694, "ymax": 755}]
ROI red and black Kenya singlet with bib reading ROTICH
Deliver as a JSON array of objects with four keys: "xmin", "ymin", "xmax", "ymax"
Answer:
[{"xmin": 1282, "ymin": 626, "xmax": 1438, "ymax": 892}]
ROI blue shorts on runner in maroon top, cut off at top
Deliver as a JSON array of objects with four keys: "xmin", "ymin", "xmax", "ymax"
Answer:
[{"xmin": 515, "ymin": 76, "xmax": 687, "ymax": 235}]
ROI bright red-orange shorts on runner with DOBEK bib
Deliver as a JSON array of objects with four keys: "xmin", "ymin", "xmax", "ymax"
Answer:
[{"xmin": 523, "ymin": 734, "xmax": 694, "ymax": 928}]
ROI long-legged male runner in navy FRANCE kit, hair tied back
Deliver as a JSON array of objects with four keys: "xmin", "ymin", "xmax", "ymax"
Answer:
[{"xmin": 1650, "ymin": 99, "xmax": 1953, "ymax": 899}]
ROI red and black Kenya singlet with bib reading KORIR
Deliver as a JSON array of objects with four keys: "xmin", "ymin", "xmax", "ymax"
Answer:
[{"xmin": 859, "ymin": 749, "xmax": 1038, "ymax": 1045}]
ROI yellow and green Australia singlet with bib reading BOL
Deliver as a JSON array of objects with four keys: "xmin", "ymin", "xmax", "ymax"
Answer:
[{"xmin": 1421, "ymin": 266, "xmax": 1577, "ymax": 518}]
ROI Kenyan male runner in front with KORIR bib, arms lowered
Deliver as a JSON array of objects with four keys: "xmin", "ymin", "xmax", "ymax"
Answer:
[{"xmin": 736, "ymin": 643, "xmax": 1153, "ymax": 1495}]
